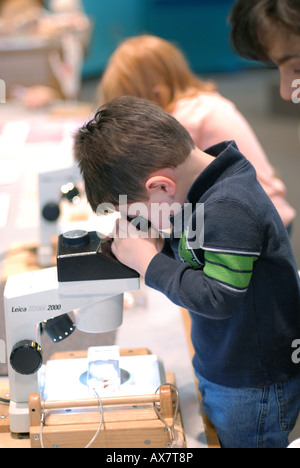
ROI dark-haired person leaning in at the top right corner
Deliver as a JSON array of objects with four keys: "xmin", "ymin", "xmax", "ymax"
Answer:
[{"xmin": 230, "ymin": 0, "xmax": 300, "ymax": 104}]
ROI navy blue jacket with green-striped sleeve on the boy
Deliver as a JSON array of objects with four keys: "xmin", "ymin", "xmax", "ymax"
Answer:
[{"xmin": 145, "ymin": 141, "xmax": 300, "ymax": 388}]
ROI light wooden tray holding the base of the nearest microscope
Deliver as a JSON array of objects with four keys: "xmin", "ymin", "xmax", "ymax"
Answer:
[{"xmin": 29, "ymin": 349, "xmax": 186, "ymax": 448}]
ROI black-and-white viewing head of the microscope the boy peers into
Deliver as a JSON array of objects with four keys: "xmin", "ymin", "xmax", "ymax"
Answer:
[{"xmin": 57, "ymin": 230, "xmax": 139, "ymax": 333}]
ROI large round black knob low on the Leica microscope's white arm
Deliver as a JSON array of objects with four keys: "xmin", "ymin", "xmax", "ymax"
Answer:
[{"xmin": 10, "ymin": 340, "xmax": 43, "ymax": 375}]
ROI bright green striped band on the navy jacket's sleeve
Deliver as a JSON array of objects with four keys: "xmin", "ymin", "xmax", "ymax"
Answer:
[{"xmin": 203, "ymin": 251, "xmax": 257, "ymax": 289}]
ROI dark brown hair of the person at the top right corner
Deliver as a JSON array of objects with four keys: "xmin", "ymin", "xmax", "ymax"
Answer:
[{"xmin": 229, "ymin": 0, "xmax": 300, "ymax": 62}]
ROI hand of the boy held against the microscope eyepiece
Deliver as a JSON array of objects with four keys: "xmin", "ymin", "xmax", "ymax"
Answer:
[{"xmin": 109, "ymin": 219, "xmax": 161, "ymax": 276}]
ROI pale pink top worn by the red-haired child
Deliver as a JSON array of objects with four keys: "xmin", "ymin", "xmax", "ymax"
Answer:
[{"xmin": 172, "ymin": 92, "xmax": 296, "ymax": 227}]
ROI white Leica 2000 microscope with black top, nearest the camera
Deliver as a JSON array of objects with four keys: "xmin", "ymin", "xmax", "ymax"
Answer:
[{"xmin": 4, "ymin": 230, "xmax": 139, "ymax": 433}]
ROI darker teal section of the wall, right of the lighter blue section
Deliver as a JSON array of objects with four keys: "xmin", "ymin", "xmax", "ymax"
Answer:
[{"xmin": 147, "ymin": 0, "xmax": 243, "ymax": 72}]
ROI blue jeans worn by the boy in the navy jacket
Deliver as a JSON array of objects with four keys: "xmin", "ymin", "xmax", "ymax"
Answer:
[{"xmin": 196, "ymin": 373, "xmax": 300, "ymax": 448}]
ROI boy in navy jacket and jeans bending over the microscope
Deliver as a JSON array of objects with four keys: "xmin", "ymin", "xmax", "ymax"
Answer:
[{"xmin": 75, "ymin": 97, "xmax": 300, "ymax": 448}]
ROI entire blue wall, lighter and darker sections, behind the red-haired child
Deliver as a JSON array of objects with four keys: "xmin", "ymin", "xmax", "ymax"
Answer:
[{"xmin": 82, "ymin": 0, "xmax": 249, "ymax": 76}]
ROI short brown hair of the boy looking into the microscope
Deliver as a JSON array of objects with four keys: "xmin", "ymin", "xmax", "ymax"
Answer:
[{"xmin": 74, "ymin": 96, "xmax": 195, "ymax": 211}]
